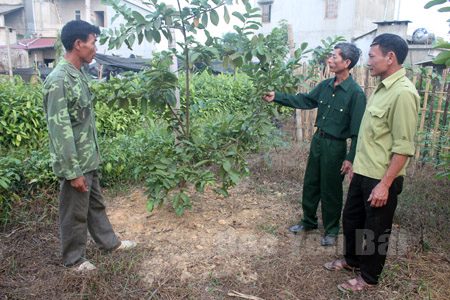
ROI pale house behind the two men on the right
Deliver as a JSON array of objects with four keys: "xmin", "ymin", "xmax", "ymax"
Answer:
[{"xmin": 254, "ymin": 0, "xmax": 440, "ymax": 65}]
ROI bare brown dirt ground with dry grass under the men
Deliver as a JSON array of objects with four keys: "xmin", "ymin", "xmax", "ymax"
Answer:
[{"xmin": 0, "ymin": 146, "xmax": 450, "ymax": 300}]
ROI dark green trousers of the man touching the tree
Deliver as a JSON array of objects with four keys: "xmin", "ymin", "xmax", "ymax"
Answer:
[{"xmin": 301, "ymin": 133, "xmax": 347, "ymax": 235}]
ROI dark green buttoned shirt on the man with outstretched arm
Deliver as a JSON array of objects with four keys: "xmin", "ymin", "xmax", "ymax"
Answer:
[{"xmin": 274, "ymin": 75, "xmax": 366, "ymax": 162}]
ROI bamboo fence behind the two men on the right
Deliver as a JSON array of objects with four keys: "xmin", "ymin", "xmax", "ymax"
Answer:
[{"xmin": 296, "ymin": 65, "xmax": 450, "ymax": 160}]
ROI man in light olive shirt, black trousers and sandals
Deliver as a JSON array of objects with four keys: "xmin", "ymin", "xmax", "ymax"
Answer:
[{"xmin": 325, "ymin": 33, "xmax": 420, "ymax": 292}]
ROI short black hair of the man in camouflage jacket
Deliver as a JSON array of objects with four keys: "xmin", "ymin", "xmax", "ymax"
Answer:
[{"xmin": 61, "ymin": 20, "xmax": 100, "ymax": 51}]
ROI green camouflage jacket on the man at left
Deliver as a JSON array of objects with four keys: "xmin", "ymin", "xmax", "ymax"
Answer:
[{"xmin": 43, "ymin": 59, "xmax": 100, "ymax": 180}]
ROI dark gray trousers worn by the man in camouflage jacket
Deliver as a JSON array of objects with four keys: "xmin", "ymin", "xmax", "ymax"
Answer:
[{"xmin": 59, "ymin": 170, "xmax": 120, "ymax": 266}]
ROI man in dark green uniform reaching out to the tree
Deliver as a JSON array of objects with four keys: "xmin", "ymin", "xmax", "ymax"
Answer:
[{"xmin": 262, "ymin": 43, "xmax": 366, "ymax": 246}]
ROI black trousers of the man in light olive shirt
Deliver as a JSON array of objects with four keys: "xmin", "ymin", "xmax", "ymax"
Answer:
[{"xmin": 342, "ymin": 174, "xmax": 403, "ymax": 284}]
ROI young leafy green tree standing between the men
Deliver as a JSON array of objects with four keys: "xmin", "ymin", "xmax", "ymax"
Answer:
[{"xmin": 100, "ymin": 0, "xmax": 342, "ymax": 215}]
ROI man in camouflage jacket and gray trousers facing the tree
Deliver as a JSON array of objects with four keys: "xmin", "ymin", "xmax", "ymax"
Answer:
[{"xmin": 43, "ymin": 20, "xmax": 136, "ymax": 271}]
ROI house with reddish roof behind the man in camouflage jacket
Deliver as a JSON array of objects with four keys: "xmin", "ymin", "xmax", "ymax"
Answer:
[{"xmin": 0, "ymin": 0, "xmax": 156, "ymax": 71}]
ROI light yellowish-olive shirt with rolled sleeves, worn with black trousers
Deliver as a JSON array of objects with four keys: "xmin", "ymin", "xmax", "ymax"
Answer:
[{"xmin": 353, "ymin": 69, "xmax": 420, "ymax": 179}]
